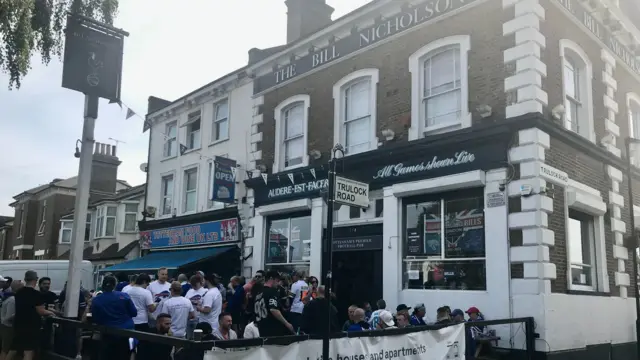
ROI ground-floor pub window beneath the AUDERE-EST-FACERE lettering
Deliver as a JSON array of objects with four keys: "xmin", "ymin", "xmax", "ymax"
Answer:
[{"xmin": 265, "ymin": 214, "xmax": 311, "ymax": 274}]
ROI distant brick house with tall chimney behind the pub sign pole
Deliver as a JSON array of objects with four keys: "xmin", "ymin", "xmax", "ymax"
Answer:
[{"xmin": 4, "ymin": 143, "xmax": 131, "ymax": 260}]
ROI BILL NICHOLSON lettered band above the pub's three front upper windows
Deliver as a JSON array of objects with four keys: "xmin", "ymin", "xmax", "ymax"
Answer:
[{"xmin": 253, "ymin": 0, "xmax": 477, "ymax": 94}]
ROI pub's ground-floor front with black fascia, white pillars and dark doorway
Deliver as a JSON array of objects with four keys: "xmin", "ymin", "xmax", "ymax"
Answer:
[{"xmin": 247, "ymin": 126, "xmax": 514, "ymax": 321}]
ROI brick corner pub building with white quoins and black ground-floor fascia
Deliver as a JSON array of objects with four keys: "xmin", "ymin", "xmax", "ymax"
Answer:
[{"xmin": 245, "ymin": 0, "xmax": 640, "ymax": 359}]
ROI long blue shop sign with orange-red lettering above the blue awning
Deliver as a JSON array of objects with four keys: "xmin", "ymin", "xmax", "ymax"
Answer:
[{"xmin": 140, "ymin": 219, "xmax": 238, "ymax": 249}]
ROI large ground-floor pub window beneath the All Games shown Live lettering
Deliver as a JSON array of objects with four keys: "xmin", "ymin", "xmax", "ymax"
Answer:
[{"xmin": 403, "ymin": 190, "xmax": 487, "ymax": 290}]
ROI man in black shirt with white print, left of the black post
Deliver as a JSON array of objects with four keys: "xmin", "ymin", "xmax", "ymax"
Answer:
[{"xmin": 254, "ymin": 270, "xmax": 294, "ymax": 337}]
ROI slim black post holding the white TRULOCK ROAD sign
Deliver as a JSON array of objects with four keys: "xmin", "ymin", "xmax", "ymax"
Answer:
[{"xmin": 322, "ymin": 144, "xmax": 344, "ymax": 360}]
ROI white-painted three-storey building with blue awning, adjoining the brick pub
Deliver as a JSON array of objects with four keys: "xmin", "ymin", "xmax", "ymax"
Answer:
[{"xmin": 101, "ymin": 71, "xmax": 253, "ymax": 279}]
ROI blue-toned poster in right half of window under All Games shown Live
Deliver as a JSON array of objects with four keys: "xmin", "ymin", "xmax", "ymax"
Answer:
[{"xmin": 445, "ymin": 209, "xmax": 484, "ymax": 258}]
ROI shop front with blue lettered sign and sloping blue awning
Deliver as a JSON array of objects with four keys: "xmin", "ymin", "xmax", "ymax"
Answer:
[{"xmin": 100, "ymin": 207, "xmax": 242, "ymax": 279}]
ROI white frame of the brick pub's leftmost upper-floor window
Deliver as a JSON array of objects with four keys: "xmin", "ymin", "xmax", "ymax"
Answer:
[{"xmin": 272, "ymin": 94, "xmax": 311, "ymax": 174}]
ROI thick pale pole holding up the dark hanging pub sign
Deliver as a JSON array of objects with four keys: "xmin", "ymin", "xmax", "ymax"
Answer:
[{"xmin": 64, "ymin": 95, "xmax": 98, "ymax": 318}]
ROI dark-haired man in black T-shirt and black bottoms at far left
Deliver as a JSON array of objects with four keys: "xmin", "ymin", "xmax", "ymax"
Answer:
[{"xmin": 6, "ymin": 270, "xmax": 53, "ymax": 360}]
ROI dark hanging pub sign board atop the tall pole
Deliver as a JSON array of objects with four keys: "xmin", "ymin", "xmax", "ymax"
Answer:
[{"xmin": 62, "ymin": 15, "xmax": 128, "ymax": 101}]
